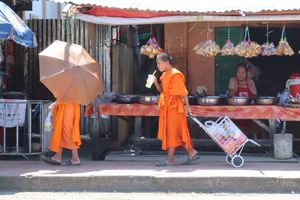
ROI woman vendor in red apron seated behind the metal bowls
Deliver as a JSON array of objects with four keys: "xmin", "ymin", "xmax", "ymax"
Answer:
[{"xmin": 228, "ymin": 63, "xmax": 257, "ymax": 97}]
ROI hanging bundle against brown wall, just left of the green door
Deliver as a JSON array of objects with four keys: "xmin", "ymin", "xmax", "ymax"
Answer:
[{"xmin": 194, "ymin": 40, "xmax": 221, "ymax": 57}]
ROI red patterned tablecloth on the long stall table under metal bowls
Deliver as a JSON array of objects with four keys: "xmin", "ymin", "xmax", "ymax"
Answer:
[{"xmin": 99, "ymin": 104, "xmax": 300, "ymax": 121}]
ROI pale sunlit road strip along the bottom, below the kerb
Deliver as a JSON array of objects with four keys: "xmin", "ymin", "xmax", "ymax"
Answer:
[{"xmin": 0, "ymin": 192, "xmax": 300, "ymax": 200}]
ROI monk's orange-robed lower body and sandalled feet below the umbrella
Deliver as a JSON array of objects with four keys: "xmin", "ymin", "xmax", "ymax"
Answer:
[{"xmin": 42, "ymin": 102, "xmax": 81, "ymax": 165}]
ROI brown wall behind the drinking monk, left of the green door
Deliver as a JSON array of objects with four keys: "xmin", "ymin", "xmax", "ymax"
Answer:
[{"xmin": 165, "ymin": 22, "xmax": 242, "ymax": 95}]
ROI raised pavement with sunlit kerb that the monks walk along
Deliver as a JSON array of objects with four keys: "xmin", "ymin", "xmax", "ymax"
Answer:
[{"xmin": 0, "ymin": 154, "xmax": 300, "ymax": 194}]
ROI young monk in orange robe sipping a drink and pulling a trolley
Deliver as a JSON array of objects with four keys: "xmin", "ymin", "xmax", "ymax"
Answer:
[{"xmin": 154, "ymin": 53, "xmax": 199, "ymax": 166}]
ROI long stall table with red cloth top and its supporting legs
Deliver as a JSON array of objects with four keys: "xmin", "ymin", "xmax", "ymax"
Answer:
[{"xmin": 99, "ymin": 103, "xmax": 300, "ymax": 153}]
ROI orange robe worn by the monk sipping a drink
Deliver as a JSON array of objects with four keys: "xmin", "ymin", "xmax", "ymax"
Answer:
[{"xmin": 157, "ymin": 69, "xmax": 193, "ymax": 150}]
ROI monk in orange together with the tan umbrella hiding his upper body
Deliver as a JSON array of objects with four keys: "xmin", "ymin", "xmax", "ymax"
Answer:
[{"xmin": 39, "ymin": 41, "xmax": 103, "ymax": 165}]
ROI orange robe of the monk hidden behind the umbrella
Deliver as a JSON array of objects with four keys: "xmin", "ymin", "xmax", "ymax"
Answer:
[{"xmin": 50, "ymin": 103, "xmax": 81, "ymax": 152}]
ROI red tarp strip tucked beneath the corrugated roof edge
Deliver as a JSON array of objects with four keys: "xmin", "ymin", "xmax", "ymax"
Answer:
[{"xmin": 84, "ymin": 7, "xmax": 178, "ymax": 18}]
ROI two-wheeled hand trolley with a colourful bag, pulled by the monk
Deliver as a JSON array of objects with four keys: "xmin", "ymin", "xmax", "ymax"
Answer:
[{"xmin": 189, "ymin": 115, "xmax": 260, "ymax": 167}]
